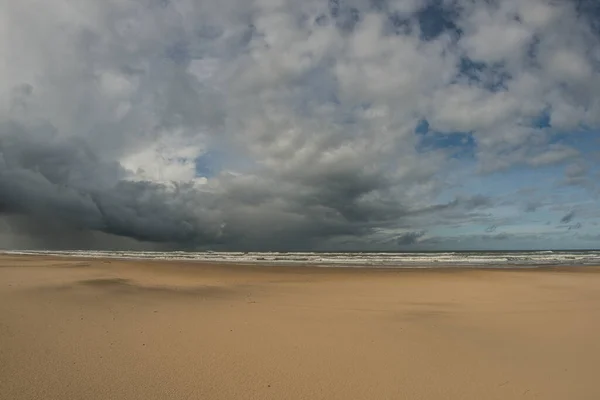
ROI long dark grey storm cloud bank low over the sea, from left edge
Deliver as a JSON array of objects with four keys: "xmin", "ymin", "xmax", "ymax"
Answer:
[{"xmin": 0, "ymin": 120, "xmax": 418, "ymax": 246}]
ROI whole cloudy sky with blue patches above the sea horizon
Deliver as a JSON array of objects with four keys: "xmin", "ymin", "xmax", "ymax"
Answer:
[{"xmin": 0, "ymin": 0, "xmax": 600, "ymax": 251}]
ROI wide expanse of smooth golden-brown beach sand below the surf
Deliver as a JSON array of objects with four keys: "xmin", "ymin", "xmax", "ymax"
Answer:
[{"xmin": 0, "ymin": 255, "xmax": 600, "ymax": 400}]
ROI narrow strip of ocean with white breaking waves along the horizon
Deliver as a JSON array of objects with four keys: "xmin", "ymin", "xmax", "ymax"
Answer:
[{"xmin": 2, "ymin": 250, "xmax": 600, "ymax": 268}]
